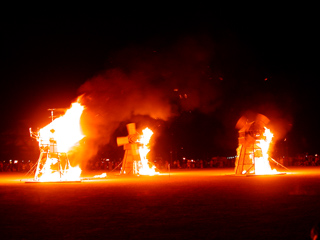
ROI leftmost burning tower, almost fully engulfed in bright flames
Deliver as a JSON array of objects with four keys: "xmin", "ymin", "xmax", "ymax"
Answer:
[{"xmin": 30, "ymin": 102, "xmax": 84, "ymax": 182}]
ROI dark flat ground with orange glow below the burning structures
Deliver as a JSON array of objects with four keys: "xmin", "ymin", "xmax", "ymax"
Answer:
[{"xmin": 0, "ymin": 167, "xmax": 320, "ymax": 239}]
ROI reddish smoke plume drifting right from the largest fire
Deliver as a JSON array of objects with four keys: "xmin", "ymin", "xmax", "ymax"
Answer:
[{"xmin": 75, "ymin": 39, "xmax": 219, "ymax": 160}]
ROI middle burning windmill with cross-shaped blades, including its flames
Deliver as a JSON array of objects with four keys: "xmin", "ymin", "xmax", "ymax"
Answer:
[{"xmin": 117, "ymin": 123, "xmax": 159, "ymax": 175}]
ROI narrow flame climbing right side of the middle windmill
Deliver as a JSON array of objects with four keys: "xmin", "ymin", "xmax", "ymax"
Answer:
[{"xmin": 139, "ymin": 128, "xmax": 159, "ymax": 176}]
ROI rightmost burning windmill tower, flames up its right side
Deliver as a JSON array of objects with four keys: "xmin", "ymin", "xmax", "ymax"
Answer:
[{"xmin": 235, "ymin": 114, "xmax": 277, "ymax": 175}]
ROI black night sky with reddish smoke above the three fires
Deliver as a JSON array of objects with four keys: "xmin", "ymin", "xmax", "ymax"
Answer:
[{"xmin": 0, "ymin": 7, "xmax": 320, "ymax": 163}]
